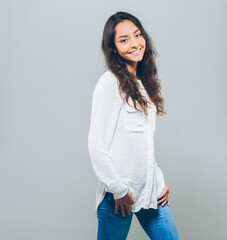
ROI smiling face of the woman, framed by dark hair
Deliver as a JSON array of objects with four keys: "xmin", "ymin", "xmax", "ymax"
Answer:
[{"xmin": 114, "ymin": 20, "xmax": 146, "ymax": 66}]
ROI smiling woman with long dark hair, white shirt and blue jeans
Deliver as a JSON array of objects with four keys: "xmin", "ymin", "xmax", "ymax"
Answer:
[{"xmin": 88, "ymin": 12, "xmax": 179, "ymax": 240}]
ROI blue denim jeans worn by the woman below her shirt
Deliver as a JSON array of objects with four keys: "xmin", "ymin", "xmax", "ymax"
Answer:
[{"xmin": 97, "ymin": 192, "xmax": 179, "ymax": 240}]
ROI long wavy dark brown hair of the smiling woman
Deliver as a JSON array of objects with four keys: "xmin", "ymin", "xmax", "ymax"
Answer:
[{"xmin": 102, "ymin": 12, "xmax": 166, "ymax": 115}]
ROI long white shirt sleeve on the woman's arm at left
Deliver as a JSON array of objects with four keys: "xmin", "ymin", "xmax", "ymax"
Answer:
[{"xmin": 88, "ymin": 72, "xmax": 128, "ymax": 199}]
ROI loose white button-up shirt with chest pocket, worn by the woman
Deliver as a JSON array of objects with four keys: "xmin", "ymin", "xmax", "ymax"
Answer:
[{"xmin": 88, "ymin": 70, "xmax": 165, "ymax": 212}]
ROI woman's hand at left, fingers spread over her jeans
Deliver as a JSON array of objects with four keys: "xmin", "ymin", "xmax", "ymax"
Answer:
[{"xmin": 115, "ymin": 191, "xmax": 135, "ymax": 217}]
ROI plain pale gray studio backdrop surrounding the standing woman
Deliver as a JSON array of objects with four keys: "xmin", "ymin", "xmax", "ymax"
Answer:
[{"xmin": 0, "ymin": 0, "xmax": 227, "ymax": 240}]
